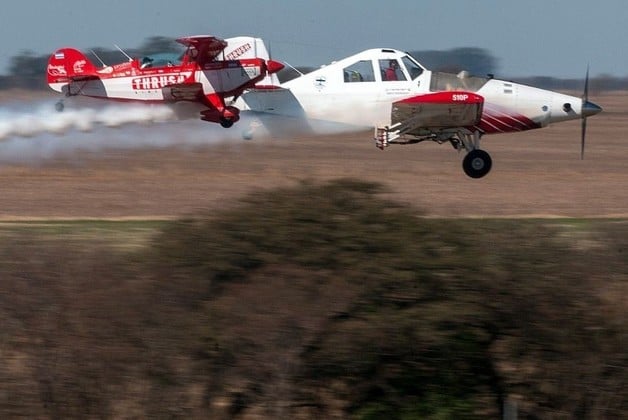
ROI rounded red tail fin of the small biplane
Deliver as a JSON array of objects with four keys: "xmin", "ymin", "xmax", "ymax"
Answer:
[{"xmin": 46, "ymin": 48, "xmax": 98, "ymax": 92}]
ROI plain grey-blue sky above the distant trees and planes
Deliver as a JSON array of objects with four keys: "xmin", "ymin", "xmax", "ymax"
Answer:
[{"xmin": 0, "ymin": 0, "xmax": 628, "ymax": 77}]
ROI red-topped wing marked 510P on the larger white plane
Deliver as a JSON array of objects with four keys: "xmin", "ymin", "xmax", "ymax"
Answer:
[{"xmin": 391, "ymin": 91, "xmax": 484, "ymax": 134}]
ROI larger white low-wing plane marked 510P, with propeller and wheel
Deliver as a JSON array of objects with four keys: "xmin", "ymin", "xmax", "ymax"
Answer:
[{"xmin": 236, "ymin": 48, "xmax": 602, "ymax": 178}]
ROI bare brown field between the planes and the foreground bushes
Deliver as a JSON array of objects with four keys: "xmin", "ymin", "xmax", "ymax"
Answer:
[{"xmin": 0, "ymin": 93, "xmax": 628, "ymax": 220}]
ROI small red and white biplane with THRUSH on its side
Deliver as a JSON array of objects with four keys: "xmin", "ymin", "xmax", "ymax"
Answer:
[{"xmin": 47, "ymin": 35, "xmax": 284, "ymax": 127}]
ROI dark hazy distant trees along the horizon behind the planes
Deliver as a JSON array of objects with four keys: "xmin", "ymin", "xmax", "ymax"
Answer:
[{"xmin": 0, "ymin": 36, "xmax": 628, "ymax": 91}]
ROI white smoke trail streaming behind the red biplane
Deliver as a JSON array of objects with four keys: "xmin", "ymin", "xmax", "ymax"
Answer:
[{"xmin": 0, "ymin": 101, "xmax": 272, "ymax": 164}]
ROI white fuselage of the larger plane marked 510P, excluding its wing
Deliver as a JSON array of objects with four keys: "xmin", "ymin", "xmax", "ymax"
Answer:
[{"xmin": 238, "ymin": 49, "xmax": 599, "ymax": 134}]
